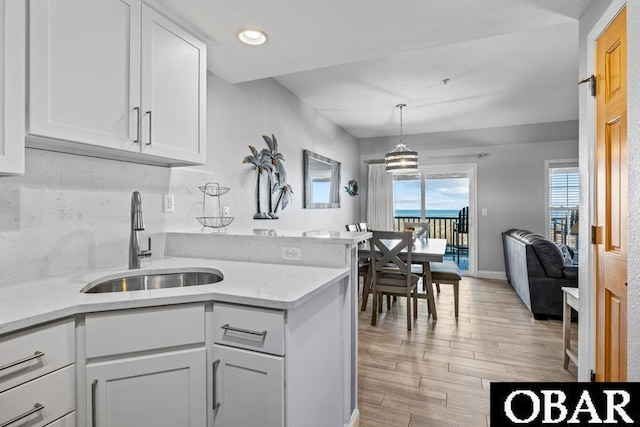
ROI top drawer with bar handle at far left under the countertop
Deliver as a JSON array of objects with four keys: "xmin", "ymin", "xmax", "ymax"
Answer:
[{"xmin": 0, "ymin": 319, "xmax": 75, "ymax": 392}]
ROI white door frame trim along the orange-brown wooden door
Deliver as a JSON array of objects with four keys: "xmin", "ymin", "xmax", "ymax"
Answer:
[{"xmin": 578, "ymin": 0, "xmax": 627, "ymax": 381}]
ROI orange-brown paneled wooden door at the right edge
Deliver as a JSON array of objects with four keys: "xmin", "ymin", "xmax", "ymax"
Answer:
[{"xmin": 595, "ymin": 5, "xmax": 628, "ymax": 381}]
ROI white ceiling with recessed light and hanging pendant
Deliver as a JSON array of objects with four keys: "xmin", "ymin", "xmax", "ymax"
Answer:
[{"xmin": 159, "ymin": 0, "xmax": 591, "ymax": 138}]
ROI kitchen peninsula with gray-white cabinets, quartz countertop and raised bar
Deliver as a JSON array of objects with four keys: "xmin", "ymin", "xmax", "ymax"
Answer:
[{"xmin": 0, "ymin": 231, "xmax": 367, "ymax": 427}]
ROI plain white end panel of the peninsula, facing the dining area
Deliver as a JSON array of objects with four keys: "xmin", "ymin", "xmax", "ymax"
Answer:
[{"xmin": 285, "ymin": 279, "xmax": 350, "ymax": 427}]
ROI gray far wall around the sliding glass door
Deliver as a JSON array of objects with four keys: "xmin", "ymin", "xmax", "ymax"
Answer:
[{"xmin": 358, "ymin": 121, "xmax": 578, "ymax": 276}]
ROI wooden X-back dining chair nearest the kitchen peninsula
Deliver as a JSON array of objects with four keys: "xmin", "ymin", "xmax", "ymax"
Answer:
[{"xmin": 369, "ymin": 230, "xmax": 420, "ymax": 331}]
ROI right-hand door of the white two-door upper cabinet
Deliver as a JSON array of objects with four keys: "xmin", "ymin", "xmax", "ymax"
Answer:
[{"xmin": 142, "ymin": 6, "xmax": 206, "ymax": 163}]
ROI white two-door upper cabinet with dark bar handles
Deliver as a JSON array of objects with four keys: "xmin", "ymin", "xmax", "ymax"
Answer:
[{"xmin": 27, "ymin": 0, "xmax": 206, "ymax": 165}]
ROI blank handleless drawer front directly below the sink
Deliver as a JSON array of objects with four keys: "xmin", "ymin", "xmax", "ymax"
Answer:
[{"xmin": 85, "ymin": 304, "xmax": 205, "ymax": 358}]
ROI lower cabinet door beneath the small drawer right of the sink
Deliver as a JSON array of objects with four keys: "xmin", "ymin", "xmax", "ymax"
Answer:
[{"xmin": 212, "ymin": 345, "xmax": 284, "ymax": 427}]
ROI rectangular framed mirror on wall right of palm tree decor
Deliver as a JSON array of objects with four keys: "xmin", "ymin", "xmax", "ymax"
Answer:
[{"xmin": 303, "ymin": 150, "xmax": 340, "ymax": 209}]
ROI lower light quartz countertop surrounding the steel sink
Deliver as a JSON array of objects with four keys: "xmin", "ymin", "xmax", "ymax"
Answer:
[{"xmin": 0, "ymin": 256, "xmax": 349, "ymax": 334}]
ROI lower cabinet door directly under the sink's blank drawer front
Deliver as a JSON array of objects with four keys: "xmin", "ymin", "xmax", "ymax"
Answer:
[{"xmin": 87, "ymin": 348, "xmax": 207, "ymax": 427}]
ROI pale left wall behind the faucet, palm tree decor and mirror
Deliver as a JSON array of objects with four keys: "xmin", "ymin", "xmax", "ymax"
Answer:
[{"xmin": 0, "ymin": 74, "xmax": 359, "ymax": 286}]
